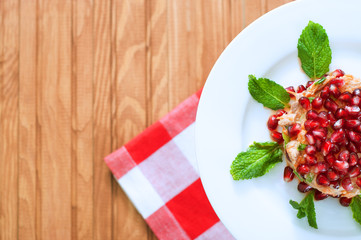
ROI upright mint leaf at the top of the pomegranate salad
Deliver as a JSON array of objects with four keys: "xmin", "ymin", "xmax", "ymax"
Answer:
[{"xmin": 297, "ymin": 21, "xmax": 332, "ymax": 78}]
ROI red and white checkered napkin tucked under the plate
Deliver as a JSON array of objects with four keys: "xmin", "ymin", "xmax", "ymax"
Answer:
[{"xmin": 105, "ymin": 91, "xmax": 233, "ymax": 240}]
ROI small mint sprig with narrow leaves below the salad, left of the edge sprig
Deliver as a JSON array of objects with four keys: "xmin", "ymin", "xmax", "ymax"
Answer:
[{"xmin": 289, "ymin": 191, "xmax": 318, "ymax": 229}]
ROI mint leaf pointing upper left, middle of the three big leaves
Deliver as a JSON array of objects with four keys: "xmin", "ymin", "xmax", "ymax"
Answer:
[{"xmin": 248, "ymin": 75, "xmax": 290, "ymax": 110}]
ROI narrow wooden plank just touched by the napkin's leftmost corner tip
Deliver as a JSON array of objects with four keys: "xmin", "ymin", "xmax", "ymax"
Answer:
[{"xmin": 93, "ymin": 0, "xmax": 113, "ymax": 240}]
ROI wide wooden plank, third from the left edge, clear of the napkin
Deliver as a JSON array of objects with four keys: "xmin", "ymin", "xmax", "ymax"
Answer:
[{"xmin": 37, "ymin": 0, "xmax": 71, "ymax": 240}]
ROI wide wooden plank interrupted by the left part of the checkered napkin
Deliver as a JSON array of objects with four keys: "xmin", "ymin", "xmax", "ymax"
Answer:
[{"xmin": 112, "ymin": 0, "xmax": 147, "ymax": 239}]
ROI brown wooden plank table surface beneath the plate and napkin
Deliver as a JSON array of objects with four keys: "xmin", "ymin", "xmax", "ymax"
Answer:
[{"xmin": 0, "ymin": 0, "xmax": 291, "ymax": 240}]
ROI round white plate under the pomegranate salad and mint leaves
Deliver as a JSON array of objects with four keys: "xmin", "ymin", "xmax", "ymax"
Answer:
[{"xmin": 196, "ymin": 0, "xmax": 361, "ymax": 240}]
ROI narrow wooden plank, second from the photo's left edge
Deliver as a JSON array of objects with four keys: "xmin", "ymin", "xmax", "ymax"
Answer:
[{"xmin": 19, "ymin": 0, "xmax": 38, "ymax": 239}]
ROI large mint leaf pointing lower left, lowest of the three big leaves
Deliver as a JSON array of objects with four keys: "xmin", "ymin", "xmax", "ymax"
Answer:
[{"xmin": 230, "ymin": 142, "xmax": 282, "ymax": 180}]
